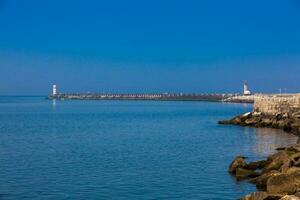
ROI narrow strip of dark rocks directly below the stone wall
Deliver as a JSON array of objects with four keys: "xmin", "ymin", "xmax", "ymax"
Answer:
[{"xmin": 219, "ymin": 112, "xmax": 300, "ymax": 136}]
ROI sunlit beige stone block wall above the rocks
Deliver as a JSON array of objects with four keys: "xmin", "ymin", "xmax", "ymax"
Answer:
[{"xmin": 254, "ymin": 94, "xmax": 300, "ymax": 115}]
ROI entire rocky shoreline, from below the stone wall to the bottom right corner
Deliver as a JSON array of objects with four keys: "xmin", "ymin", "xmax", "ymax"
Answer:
[{"xmin": 219, "ymin": 112, "xmax": 300, "ymax": 200}]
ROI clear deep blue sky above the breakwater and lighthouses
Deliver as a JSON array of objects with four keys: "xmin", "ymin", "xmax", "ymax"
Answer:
[{"xmin": 0, "ymin": 0, "xmax": 300, "ymax": 95}]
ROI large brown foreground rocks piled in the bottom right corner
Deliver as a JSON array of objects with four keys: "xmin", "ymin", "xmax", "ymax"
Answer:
[{"xmin": 228, "ymin": 139, "xmax": 300, "ymax": 200}]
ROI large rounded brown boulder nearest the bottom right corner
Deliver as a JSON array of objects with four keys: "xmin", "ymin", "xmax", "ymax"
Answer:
[{"xmin": 267, "ymin": 174, "xmax": 297, "ymax": 195}]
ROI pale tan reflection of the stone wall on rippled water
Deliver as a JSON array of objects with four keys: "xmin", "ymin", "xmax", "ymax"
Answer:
[{"xmin": 248, "ymin": 128, "xmax": 297, "ymax": 156}]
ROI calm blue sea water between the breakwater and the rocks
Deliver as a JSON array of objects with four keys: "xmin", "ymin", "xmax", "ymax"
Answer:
[{"xmin": 0, "ymin": 97, "xmax": 296, "ymax": 200}]
